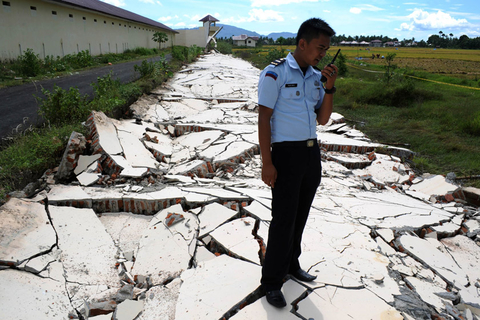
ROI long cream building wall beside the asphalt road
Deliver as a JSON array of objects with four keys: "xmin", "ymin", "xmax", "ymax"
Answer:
[{"xmin": 0, "ymin": 0, "xmax": 175, "ymax": 60}]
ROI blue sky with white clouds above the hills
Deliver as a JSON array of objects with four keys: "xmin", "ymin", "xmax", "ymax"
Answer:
[{"xmin": 103, "ymin": 0, "xmax": 480, "ymax": 40}]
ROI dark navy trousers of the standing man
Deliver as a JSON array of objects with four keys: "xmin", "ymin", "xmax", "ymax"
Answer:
[{"xmin": 261, "ymin": 142, "xmax": 322, "ymax": 291}]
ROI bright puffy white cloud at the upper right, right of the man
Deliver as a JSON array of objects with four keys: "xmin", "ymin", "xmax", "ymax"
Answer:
[{"xmin": 395, "ymin": 9, "xmax": 469, "ymax": 31}]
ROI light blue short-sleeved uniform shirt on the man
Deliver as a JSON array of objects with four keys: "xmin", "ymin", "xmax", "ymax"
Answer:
[{"xmin": 258, "ymin": 53, "xmax": 325, "ymax": 143}]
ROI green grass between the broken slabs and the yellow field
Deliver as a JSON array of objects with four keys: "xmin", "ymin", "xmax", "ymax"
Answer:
[{"xmin": 335, "ymin": 72, "xmax": 480, "ymax": 186}]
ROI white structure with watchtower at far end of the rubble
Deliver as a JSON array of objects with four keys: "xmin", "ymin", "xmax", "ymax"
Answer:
[{"xmin": 175, "ymin": 15, "xmax": 223, "ymax": 48}]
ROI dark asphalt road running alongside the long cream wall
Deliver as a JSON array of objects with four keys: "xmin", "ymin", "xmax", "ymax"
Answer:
[{"xmin": 0, "ymin": 55, "xmax": 171, "ymax": 143}]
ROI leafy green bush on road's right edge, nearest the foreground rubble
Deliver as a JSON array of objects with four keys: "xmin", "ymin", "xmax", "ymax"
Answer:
[{"xmin": 35, "ymin": 85, "xmax": 89, "ymax": 125}]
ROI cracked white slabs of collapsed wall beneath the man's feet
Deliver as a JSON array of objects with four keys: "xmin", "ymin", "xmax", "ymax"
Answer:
[{"xmin": 0, "ymin": 53, "xmax": 480, "ymax": 320}]
